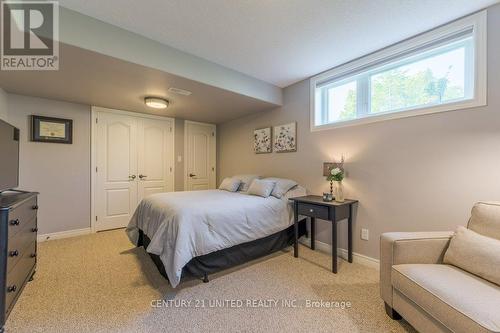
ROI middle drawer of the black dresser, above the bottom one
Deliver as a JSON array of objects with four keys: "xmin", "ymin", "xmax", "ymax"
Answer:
[{"xmin": 7, "ymin": 218, "xmax": 37, "ymax": 272}]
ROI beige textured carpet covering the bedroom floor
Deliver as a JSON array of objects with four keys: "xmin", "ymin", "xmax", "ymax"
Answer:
[{"xmin": 6, "ymin": 230, "xmax": 414, "ymax": 332}]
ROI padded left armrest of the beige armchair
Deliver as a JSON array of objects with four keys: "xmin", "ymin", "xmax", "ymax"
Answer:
[{"xmin": 380, "ymin": 231, "xmax": 453, "ymax": 307}]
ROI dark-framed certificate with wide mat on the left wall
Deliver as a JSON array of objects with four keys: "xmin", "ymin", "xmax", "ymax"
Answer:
[{"xmin": 31, "ymin": 116, "xmax": 73, "ymax": 144}]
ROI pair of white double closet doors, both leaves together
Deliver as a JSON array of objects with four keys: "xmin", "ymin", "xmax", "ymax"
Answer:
[{"xmin": 94, "ymin": 111, "xmax": 174, "ymax": 231}]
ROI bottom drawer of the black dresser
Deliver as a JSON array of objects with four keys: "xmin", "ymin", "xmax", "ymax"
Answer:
[{"xmin": 5, "ymin": 243, "xmax": 36, "ymax": 314}]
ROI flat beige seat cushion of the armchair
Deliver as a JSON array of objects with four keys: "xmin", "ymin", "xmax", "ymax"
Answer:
[{"xmin": 392, "ymin": 264, "xmax": 500, "ymax": 332}]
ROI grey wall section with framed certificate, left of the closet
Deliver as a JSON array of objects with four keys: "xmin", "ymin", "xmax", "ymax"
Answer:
[{"xmin": 8, "ymin": 94, "xmax": 90, "ymax": 234}]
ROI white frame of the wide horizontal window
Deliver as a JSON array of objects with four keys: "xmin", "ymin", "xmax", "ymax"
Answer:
[{"xmin": 310, "ymin": 10, "xmax": 487, "ymax": 132}]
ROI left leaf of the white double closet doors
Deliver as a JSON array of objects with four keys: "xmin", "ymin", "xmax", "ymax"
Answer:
[{"xmin": 94, "ymin": 112, "xmax": 137, "ymax": 231}]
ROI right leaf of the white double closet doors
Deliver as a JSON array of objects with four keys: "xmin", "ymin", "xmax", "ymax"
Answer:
[{"xmin": 137, "ymin": 118, "xmax": 174, "ymax": 202}]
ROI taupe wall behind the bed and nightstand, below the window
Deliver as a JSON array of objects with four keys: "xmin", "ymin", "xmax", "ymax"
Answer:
[{"xmin": 218, "ymin": 6, "xmax": 500, "ymax": 258}]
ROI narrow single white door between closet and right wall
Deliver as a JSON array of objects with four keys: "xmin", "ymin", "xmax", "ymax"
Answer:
[{"xmin": 184, "ymin": 121, "xmax": 216, "ymax": 191}]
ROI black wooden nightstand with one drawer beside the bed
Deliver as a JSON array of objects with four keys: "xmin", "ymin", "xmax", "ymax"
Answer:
[{"xmin": 290, "ymin": 195, "xmax": 358, "ymax": 273}]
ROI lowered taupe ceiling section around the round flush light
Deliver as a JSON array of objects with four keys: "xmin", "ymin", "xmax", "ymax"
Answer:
[{"xmin": 0, "ymin": 44, "xmax": 276, "ymax": 123}]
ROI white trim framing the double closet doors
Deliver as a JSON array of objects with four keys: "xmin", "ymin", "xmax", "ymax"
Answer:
[{"xmin": 90, "ymin": 106, "xmax": 175, "ymax": 233}]
